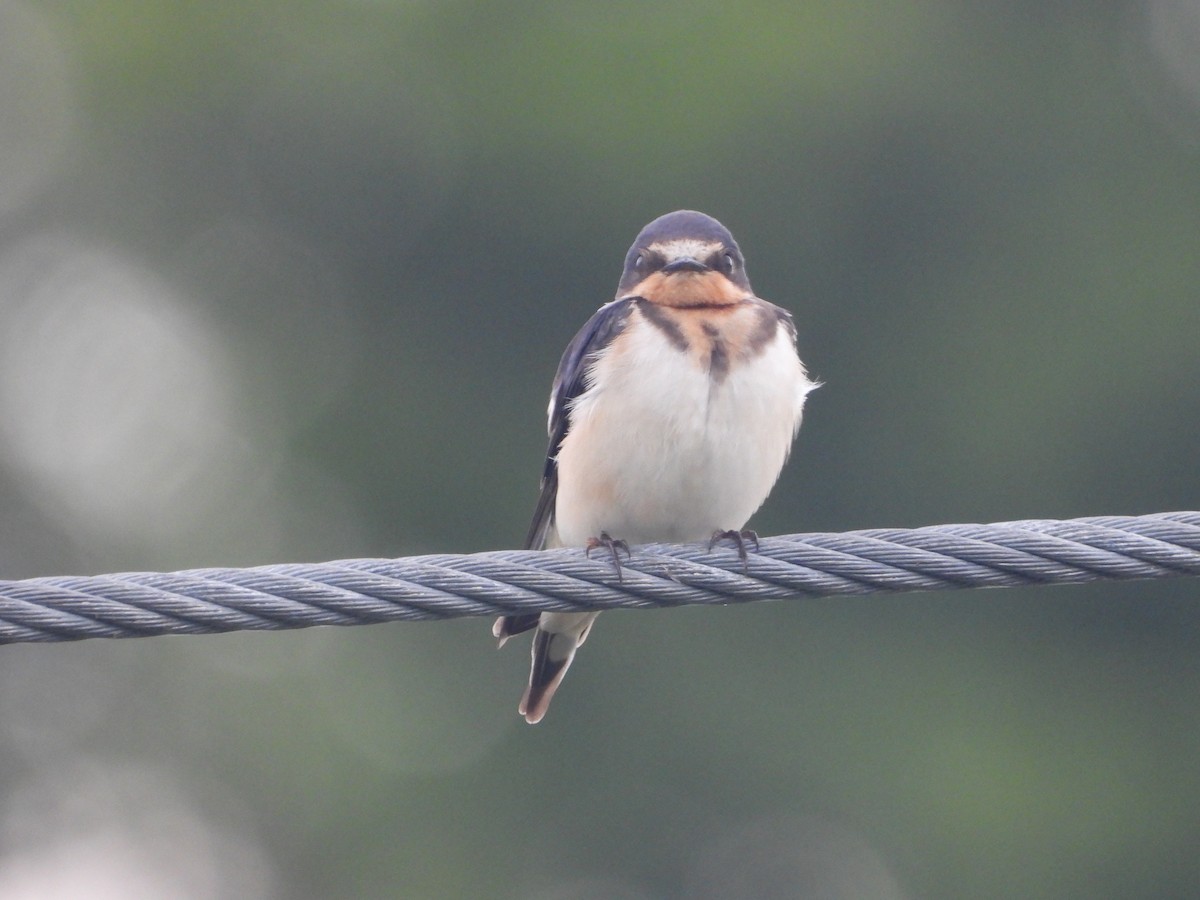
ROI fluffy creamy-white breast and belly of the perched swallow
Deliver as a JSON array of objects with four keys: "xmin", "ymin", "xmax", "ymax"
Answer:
[{"xmin": 556, "ymin": 312, "xmax": 814, "ymax": 546}]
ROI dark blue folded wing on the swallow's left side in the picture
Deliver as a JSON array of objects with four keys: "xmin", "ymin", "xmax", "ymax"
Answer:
[{"xmin": 524, "ymin": 298, "xmax": 634, "ymax": 550}]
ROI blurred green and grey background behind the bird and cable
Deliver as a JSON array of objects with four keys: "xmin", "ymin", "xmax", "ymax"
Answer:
[{"xmin": 0, "ymin": 0, "xmax": 1200, "ymax": 900}]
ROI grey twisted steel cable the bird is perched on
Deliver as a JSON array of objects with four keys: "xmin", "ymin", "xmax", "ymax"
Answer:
[{"xmin": 0, "ymin": 512, "xmax": 1200, "ymax": 643}]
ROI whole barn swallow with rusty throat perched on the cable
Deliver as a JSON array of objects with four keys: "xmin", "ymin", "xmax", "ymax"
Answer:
[{"xmin": 492, "ymin": 210, "xmax": 816, "ymax": 724}]
